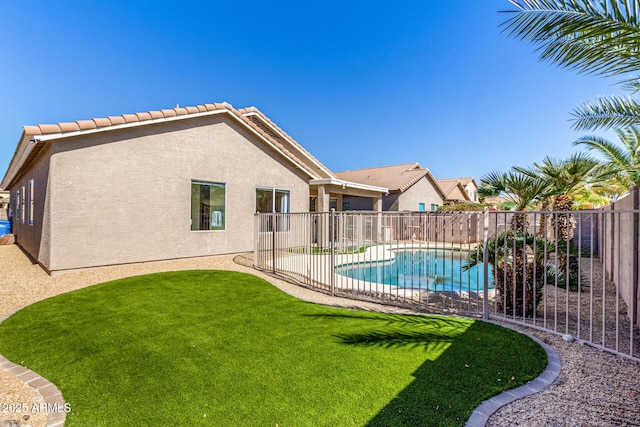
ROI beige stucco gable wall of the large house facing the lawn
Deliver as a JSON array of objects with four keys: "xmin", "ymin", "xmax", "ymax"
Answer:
[{"xmin": 12, "ymin": 115, "xmax": 309, "ymax": 271}]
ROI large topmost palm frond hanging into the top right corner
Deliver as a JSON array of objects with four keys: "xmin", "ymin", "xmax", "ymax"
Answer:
[{"xmin": 502, "ymin": 0, "xmax": 640, "ymax": 76}]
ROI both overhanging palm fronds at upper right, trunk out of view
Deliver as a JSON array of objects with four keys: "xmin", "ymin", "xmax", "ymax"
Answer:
[{"xmin": 503, "ymin": 0, "xmax": 640, "ymax": 130}]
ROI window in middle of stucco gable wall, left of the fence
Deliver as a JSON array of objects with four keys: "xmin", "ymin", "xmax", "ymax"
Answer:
[{"xmin": 191, "ymin": 181, "xmax": 226, "ymax": 231}]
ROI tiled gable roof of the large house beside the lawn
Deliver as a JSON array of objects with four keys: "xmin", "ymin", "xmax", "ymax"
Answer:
[{"xmin": 0, "ymin": 102, "xmax": 335, "ymax": 188}]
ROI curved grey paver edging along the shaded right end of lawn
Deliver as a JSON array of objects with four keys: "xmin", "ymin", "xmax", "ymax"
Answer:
[{"xmin": 465, "ymin": 321, "xmax": 562, "ymax": 427}]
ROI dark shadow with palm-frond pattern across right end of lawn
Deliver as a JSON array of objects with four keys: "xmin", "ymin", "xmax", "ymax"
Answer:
[{"xmin": 310, "ymin": 313, "xmax": 546, "ymax": 427}]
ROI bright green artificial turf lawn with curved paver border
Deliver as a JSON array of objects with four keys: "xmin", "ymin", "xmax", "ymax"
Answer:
[{"xmin": 0, "ymin": 271, "xmax": 546, "ymax": 427}]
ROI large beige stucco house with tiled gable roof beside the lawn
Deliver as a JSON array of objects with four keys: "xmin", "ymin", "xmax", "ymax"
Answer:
[{"xmin": 0, "ymin": 103, "xmax": 387, "ymax": 273}]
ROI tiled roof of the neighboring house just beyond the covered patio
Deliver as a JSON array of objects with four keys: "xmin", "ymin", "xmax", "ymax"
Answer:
[{"xmin": 335, "ymin": 162, "xmax": 445, "ymax": 196}]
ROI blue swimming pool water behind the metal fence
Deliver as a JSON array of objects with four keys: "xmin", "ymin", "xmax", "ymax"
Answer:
[{"xmin": 336, "ymin": 250, "xmax": 493, "ymax": 292}]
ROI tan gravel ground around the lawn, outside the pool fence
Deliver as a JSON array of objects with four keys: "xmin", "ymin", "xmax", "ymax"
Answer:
[{"xmin": 0, "ymin": 245, "xmax": 640, "ymax": 426}]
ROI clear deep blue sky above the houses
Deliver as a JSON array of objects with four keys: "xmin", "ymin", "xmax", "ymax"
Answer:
[{"xmin": 0, "ymin": 0, "xmax": 621, "ymax": 179}]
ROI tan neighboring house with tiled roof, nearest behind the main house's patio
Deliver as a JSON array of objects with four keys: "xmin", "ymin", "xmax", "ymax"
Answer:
[{"xmin": 336, "ymin": 163, "xmax": 445, "ymax": 211}]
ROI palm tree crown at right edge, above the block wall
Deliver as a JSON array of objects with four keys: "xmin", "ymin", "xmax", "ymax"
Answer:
[{"xmin": 573, "ymin": 126, "xmax": 640, "ymax": 190}]
